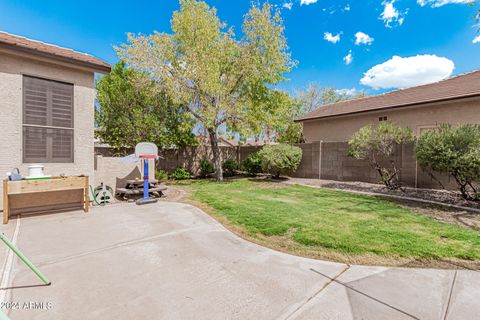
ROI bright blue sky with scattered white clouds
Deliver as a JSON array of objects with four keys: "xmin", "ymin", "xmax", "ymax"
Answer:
[{"xmin": 0, "ymin": 0, "xmax": 480, "ymax": 94}]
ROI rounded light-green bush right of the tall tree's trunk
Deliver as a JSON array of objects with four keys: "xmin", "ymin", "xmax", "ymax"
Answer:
[{"xmin": 258, "ymin": 144, "xmax": 302, "ymax": 179}]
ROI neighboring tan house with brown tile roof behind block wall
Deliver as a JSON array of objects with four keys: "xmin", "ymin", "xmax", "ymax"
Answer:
[{"xmin": 296, "ymin": 71, "xmax": 480, "ymax": 142}]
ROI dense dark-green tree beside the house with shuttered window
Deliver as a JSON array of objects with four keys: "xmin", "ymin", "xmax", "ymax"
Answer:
[{"xmin": 95, "ymin": 62, "xmax": 195, "ymax": 149}]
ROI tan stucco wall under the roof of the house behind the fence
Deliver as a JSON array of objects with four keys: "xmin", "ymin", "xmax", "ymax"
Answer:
[{"xmin": 303, "ymin": 98, "xmax": 480, "ymax": 143}]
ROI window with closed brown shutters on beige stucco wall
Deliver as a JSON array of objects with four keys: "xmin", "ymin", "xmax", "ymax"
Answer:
[{"xmin": 23, "ymin": 76, "xmax": 73, "ymax": 163}]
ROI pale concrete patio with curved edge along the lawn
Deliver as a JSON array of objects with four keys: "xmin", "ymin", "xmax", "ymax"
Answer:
[{"xmin": 0, "ymin": 202, "xmax": 480, "ymax": 320}]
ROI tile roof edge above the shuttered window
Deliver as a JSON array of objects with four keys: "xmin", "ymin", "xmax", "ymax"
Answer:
[{"xmin": 0, "ymin": 31, "xmax": 111, "ymax": 73}]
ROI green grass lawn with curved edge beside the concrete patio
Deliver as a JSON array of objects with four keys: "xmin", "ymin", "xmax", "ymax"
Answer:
[{"xmin": 188, "ymin": 179, "xmax": 480, "ymax": 260}]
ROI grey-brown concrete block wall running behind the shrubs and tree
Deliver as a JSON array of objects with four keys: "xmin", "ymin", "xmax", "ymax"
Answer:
[{"xmin": 95, "ymin": 141, "xmax": 456, "ymax": 189}]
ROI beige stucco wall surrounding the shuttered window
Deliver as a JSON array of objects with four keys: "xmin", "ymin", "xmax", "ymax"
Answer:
[{"xmin": 0, "ymin": 51, "xmax": 95, "ymax": 209}]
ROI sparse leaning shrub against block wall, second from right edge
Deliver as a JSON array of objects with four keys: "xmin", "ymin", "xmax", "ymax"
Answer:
[{"xmin": 348, "ymin": 121, "xmax": 415, "ymax": 190}]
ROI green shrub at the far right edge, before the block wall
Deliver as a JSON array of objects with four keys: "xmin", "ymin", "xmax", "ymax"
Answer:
[{"xmin": 415, "ymin": 124, "xmax": 480, "ymax": 201}]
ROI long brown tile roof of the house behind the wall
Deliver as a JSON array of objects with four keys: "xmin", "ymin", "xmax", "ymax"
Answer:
[{"xmin": 295, "ymin": 70, "xmax": 480, "ymax": 122}]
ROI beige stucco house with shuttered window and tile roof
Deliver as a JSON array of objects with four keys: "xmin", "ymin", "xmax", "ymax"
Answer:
[{"xmin": 0, "ymin": 32, "xmax": 110, "ymax": 208}]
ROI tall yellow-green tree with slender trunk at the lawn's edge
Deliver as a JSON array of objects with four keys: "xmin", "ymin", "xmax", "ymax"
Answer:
[{"xmin": 118, "ymin": 0, "xmax": 295, "ymax": 180}]
